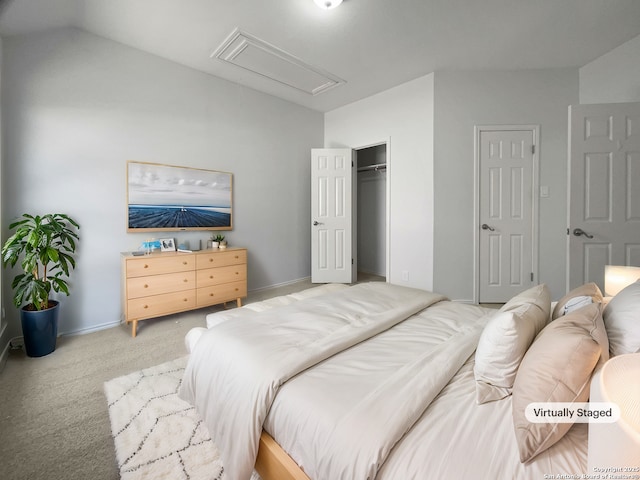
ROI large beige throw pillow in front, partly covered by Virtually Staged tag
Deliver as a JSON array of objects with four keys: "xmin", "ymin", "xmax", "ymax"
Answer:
[{"xmin": 512, "ymin": 303, "xmax": 609, "ymax": 462}]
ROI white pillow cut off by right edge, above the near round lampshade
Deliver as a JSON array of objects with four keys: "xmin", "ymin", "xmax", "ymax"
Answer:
[{"xmin": 602, "ymin": 280, "xmax": 640, "ymax": 357}]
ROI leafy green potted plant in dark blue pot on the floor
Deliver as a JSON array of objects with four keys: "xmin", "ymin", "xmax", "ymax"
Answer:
[{"xmin": 2, "ymin": 213, "xmax": 80, "ymax": 357}]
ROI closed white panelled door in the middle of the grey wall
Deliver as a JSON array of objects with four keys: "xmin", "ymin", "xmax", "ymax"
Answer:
[{"xmin": 476, "ymin": 127, "xmax": 538, "ymax": 303}]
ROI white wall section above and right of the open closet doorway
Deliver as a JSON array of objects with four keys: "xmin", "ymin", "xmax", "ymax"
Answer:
[{"xmin": 325, "ymin": 74, "xmax": 434, "ymax": 290}]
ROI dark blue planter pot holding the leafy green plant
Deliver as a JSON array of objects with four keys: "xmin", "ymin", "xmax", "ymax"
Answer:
[{"xmin": 20, "ymin": 300, "xmax": 60, "ymax": 357}]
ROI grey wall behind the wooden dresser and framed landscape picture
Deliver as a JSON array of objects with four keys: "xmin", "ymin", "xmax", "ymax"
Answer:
[{"xmin": 2, "ymin": 29, "xmax": 323, "ymax": 342}]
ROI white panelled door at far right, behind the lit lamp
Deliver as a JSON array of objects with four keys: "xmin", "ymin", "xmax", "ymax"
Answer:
[{"xmin": 567, "ymin": 103, "xmax": 640, "ymax": 291}]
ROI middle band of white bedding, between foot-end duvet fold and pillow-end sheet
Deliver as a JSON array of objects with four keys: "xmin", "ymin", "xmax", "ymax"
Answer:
[{"xmin": 265, "ymin": 302, "xmax": 485, "ymax": 480}]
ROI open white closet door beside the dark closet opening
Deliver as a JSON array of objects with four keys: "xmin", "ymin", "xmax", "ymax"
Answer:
[{"xmin": 311, "ymin": 148, "xmax": 357, "ymax": 283}]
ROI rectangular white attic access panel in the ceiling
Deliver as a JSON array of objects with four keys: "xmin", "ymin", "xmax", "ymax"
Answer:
[{"xmin": 211, "ymin": 28, "xmax": 345, "ymax": 95}]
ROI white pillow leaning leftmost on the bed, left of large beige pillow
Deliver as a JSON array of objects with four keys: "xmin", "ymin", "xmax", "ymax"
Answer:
[{"xmin": 474, "ymin": 284, "xmax": 551, "ymax": 404}]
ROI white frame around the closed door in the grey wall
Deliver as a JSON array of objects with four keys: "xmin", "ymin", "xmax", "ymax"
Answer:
[{"xmin": 473, "ymin": 124, "xmax": 540, "ymax": 303}]
